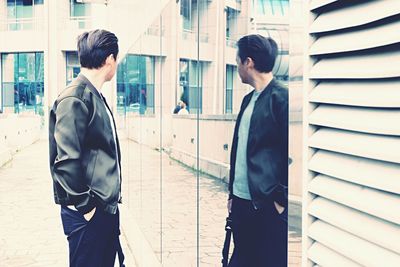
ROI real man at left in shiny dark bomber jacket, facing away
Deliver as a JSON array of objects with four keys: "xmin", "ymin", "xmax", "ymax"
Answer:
[{"xmin": 49, "ymin": 30, "xmax": 124, "ymax": 267}]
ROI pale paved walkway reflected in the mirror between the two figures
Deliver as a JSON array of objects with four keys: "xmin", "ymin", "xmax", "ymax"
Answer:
[{"xmin": 121, "ymin": 140, "xmax": 301, "ymax": 267}]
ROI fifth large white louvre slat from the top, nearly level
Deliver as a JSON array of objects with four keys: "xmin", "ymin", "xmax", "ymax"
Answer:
[{"xmin": 309, "ymin": 105, "xmax": 400, "ymax": 135}]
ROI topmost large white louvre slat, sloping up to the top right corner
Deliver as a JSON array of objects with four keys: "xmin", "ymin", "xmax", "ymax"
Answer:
[{"xmin": 309, "ymin": 0, "xmax": 400, "ymax": 33}]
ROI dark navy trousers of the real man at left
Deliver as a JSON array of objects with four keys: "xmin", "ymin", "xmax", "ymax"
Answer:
[{"xmin": 61, "ymin": 206, "xmax": 124, "ymax": 267}]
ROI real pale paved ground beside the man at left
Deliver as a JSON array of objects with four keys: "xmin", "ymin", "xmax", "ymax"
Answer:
[{"xmin": 0, "ymin": 141, "xmax": 135, "ymax": 267}]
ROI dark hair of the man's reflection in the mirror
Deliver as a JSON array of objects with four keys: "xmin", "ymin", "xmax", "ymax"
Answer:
[{"xmin": 237, "ymin": 34, "xmax": 278, "ymax": 72}]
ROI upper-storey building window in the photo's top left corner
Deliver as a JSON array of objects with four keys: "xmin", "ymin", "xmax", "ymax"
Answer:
[{"xmin": 3, "ymin": 0, "xmax": 43, "ymax": 31}]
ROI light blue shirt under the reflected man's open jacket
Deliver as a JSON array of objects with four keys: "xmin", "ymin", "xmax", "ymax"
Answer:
[{"xmin": 233, "ymin": 91, "xmax": 261, "ymax": 200}]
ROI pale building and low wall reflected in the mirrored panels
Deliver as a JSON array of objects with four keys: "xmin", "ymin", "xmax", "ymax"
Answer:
[{"xmin": 117, "ymin": 0, "xmax": 290, "ymax": 191}]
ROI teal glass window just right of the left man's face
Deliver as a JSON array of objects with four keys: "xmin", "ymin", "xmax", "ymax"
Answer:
[{"xmin": 117, "ymin": 55, "xmax": 155, "ymax": 114}]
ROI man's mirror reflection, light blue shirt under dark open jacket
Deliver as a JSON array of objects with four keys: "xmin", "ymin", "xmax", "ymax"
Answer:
[{"xmin": 228, "ymin": 35, "xmax": 288, "ymax": 267}]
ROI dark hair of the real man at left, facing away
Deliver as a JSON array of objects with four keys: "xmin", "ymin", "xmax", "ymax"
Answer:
[{"xmin": 78, "ymin": 30, "xmax": 118, "ymax": 69}]
